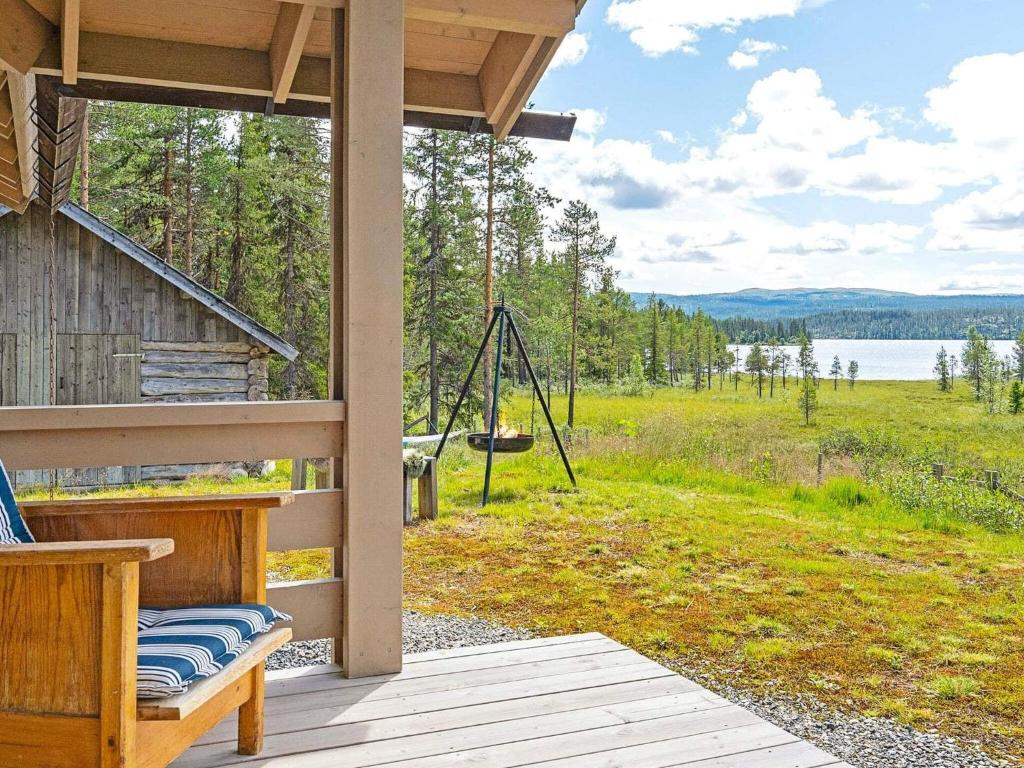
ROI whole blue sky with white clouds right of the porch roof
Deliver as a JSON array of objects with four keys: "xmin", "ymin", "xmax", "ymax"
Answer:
[{"xmin": 535, "ymin": 0, "xmax": 1024, "ymax": 293}]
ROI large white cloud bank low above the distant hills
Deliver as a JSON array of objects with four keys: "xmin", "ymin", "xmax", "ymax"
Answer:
[{"xmin": 536, "ymin": 54, "xmax": 1024, "ymax": 291}]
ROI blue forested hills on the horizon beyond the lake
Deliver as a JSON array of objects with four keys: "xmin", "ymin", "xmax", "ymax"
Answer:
[{"xmin": 633, "ymin": 288, "xmax": 1024, "ymax": 340}]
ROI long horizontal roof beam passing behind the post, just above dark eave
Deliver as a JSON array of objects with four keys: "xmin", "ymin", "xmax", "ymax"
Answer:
[{"xmin": 33, "ymin": 32, "xmax": 484, "ymax": 117}]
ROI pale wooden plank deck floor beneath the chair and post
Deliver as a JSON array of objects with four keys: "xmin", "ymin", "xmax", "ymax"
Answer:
[{"xmin": 172, "ymin": 634, "xmax": 850, "ymax": 768}]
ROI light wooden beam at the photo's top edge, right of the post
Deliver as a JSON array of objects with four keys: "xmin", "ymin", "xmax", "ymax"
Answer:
[{"xmin": 406, "ymin": 0, "xmax": 577, "ymax": 37}]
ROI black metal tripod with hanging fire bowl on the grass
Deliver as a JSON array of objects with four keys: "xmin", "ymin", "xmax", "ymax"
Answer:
[{"xmin": 434, "ymin": 299, "xmax": 577, "ymax": 507}]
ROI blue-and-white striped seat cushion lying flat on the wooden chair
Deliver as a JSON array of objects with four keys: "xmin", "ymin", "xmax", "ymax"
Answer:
[{"xmin": 138, "ymin": 605, "xmax": 291, "ymax": 698}]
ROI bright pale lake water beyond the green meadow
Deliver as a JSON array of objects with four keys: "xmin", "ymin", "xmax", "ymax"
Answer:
[{"xmin": 730, "ymin": 339, "xmax": 1014, "ymax": 381}]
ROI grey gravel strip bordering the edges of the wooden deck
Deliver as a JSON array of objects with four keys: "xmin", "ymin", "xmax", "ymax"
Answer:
[{"xmin": 267, "ymin": 610, "xmax": 1018, "ymax": 768}]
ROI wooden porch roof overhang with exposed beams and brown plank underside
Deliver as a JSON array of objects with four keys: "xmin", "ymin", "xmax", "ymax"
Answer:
[{"xmin": 0, "ymin": 0, "xmax": 585, "ymax": 210}]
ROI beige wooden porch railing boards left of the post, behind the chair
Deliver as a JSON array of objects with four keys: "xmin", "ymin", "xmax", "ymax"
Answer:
[{"xmin": 0, "ymin": 401, "xmax": 345, "ymax": 647}]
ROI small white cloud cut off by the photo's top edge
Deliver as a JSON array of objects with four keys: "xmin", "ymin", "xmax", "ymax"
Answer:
[{"xmin": 607, "ymin": 0, "xmax": 827, "ymax": 56}]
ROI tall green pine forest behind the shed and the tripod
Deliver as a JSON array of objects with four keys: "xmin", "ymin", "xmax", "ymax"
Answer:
[{"xmin": 76, "ymin": 102, "xmax": 770, "ymax": 424}]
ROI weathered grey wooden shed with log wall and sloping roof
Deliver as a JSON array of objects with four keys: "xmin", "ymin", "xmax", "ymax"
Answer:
[{"xmin": 0, "ymin": 202, "xmax": 298, "ymax": 485}]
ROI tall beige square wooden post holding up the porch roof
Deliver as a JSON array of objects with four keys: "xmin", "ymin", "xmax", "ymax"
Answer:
[{"xmin": 331, "ymin": 0, "xmax": 404, "ymax": 677}]
